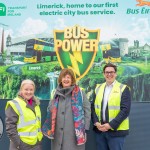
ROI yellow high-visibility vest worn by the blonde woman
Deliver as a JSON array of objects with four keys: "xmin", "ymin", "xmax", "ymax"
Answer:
[{"xmin": 5, "ymin": 97, "xmax": 43, "ymax": 145}]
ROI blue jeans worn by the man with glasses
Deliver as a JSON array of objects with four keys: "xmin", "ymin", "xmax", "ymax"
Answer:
[{"xmin": 96, "ymin": 132, "xmax": 125, "ymax": 150}]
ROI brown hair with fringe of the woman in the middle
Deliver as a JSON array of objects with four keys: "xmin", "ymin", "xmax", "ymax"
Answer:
[{"xmin": 58, "ymin": 68, "xmax": 76, "ymax": 85}]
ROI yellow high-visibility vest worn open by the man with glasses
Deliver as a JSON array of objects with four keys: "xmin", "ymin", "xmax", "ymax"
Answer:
[{"xmin": 94, "ymin": 81, "xmax": 129, "ymax": 130}]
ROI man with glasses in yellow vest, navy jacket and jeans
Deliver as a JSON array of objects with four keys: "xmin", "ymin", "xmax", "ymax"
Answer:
[{"xmin": 91, "ymin": 63, "xmax": 131, "ymax": 150}]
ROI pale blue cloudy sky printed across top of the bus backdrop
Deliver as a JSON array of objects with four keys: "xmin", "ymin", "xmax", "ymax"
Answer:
[{"xmin": 0, "ymin": 0, "xmax": 150, "ymax": 45}]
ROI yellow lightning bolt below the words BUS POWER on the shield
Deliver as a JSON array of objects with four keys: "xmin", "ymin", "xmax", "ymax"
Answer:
[{"xmin": 68, "ymin": 51, "xmax": 83, "ymax": 76}]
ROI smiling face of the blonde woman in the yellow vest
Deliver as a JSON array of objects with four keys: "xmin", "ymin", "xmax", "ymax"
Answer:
[{"xmin": 20, "ymin": 83, "xmax": 35, "ymax": 100}]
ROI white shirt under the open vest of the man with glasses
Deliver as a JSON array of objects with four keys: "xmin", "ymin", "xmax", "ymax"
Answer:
[{"xmin": 102, "ymin": 80, "xmax": 116, "ymax": 121}]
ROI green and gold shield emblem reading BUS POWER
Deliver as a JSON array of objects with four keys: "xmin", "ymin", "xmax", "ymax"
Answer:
[{"xmin": 54, "ymin": 25, "xmax": 100, "ymax": 80}]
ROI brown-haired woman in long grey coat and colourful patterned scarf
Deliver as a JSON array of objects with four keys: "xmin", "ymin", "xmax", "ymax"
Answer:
[{"xmin": 42, "ymin": 69, "xmax": 91, "ymax": 150}]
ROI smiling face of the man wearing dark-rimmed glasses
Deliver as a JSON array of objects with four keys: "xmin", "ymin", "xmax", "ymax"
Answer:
[{"xmin": 104, "ymin": 67, "xmax": 117, "ymax": 85}]
